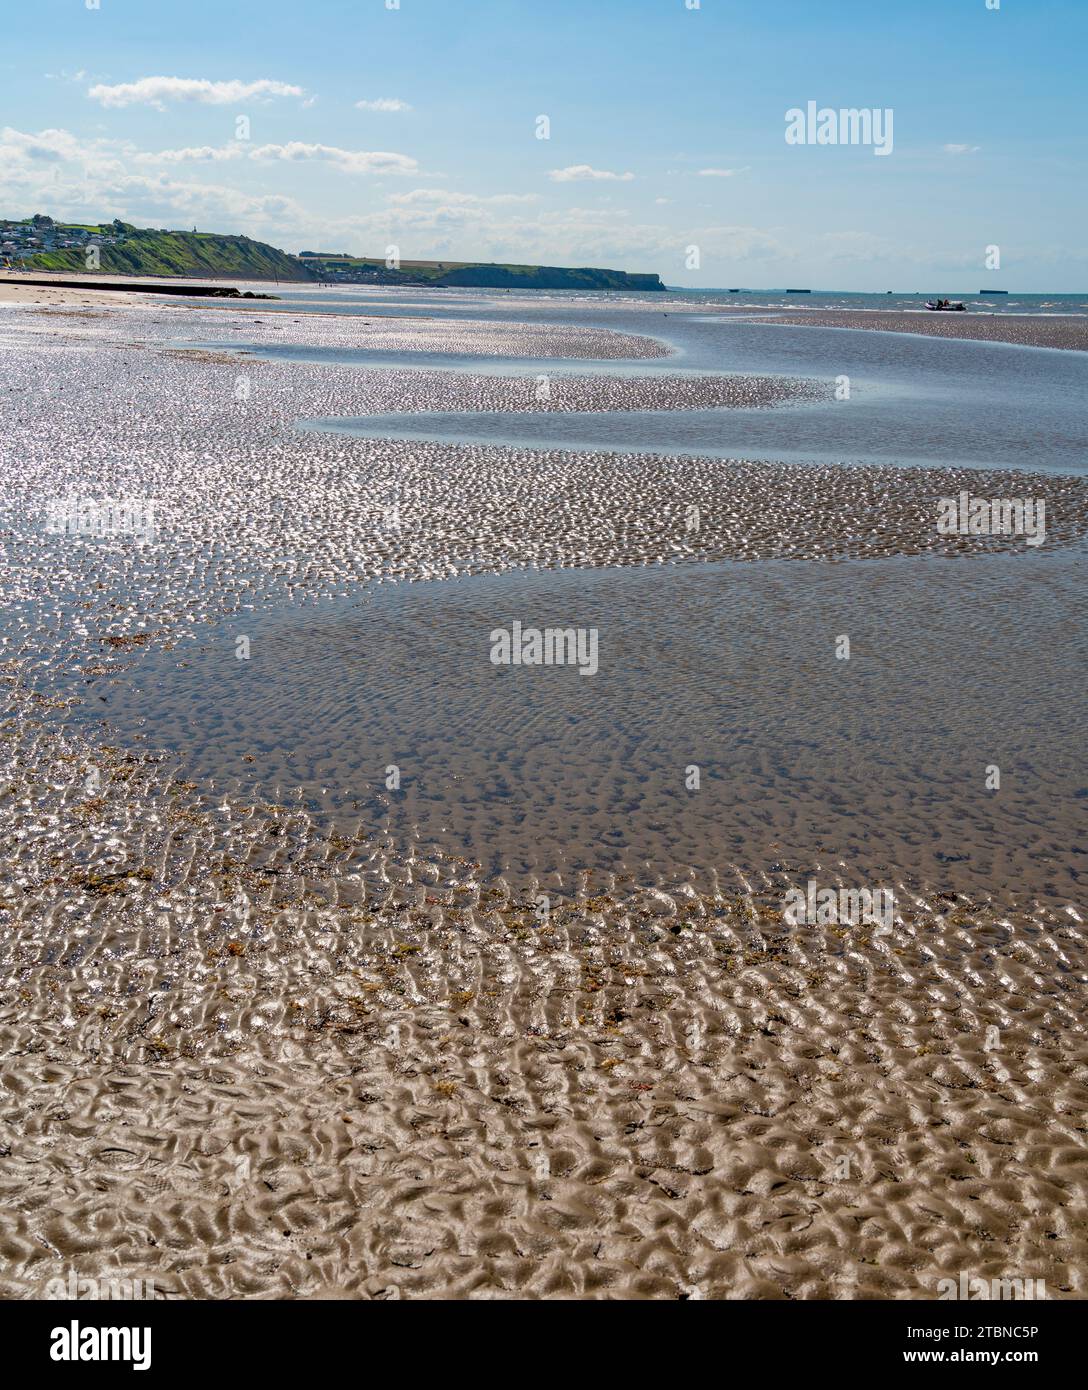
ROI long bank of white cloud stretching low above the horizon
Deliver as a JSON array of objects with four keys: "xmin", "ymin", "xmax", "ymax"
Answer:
[{"xmin": 0, "ymin": 126, "xmax": 1056, "ymax": 284}]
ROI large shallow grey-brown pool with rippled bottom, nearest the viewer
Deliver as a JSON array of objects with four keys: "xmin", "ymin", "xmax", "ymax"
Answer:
[{"xmin": 72, "ymin": 550, "xmax": 1088, "ymax": 901}]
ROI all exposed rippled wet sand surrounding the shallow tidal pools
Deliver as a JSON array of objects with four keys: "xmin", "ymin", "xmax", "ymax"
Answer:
[{"xmin": 0, "ymin": 298, "xmax": 1088, "ymax": 1298}]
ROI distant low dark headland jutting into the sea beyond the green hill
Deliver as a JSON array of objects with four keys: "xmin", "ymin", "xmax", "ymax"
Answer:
[{"xmin": 299, "ymin": 252, "xmax": 666, "ymax": 293}]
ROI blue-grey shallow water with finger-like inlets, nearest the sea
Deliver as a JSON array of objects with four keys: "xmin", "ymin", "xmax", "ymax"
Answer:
[{"xmin": 232, "ymin": 307, "xmax": 1088, "ymax": 474}]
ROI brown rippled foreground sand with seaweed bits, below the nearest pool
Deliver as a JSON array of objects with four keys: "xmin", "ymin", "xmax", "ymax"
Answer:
[{"xmin": 0, "ymin": 711, "xmax": 1088, "ymax": 1298}]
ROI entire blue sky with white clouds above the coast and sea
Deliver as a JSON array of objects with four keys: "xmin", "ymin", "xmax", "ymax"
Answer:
[{"xmin": 0, "ymin": 0, "xmax": 1088, "ymax": 293}]
